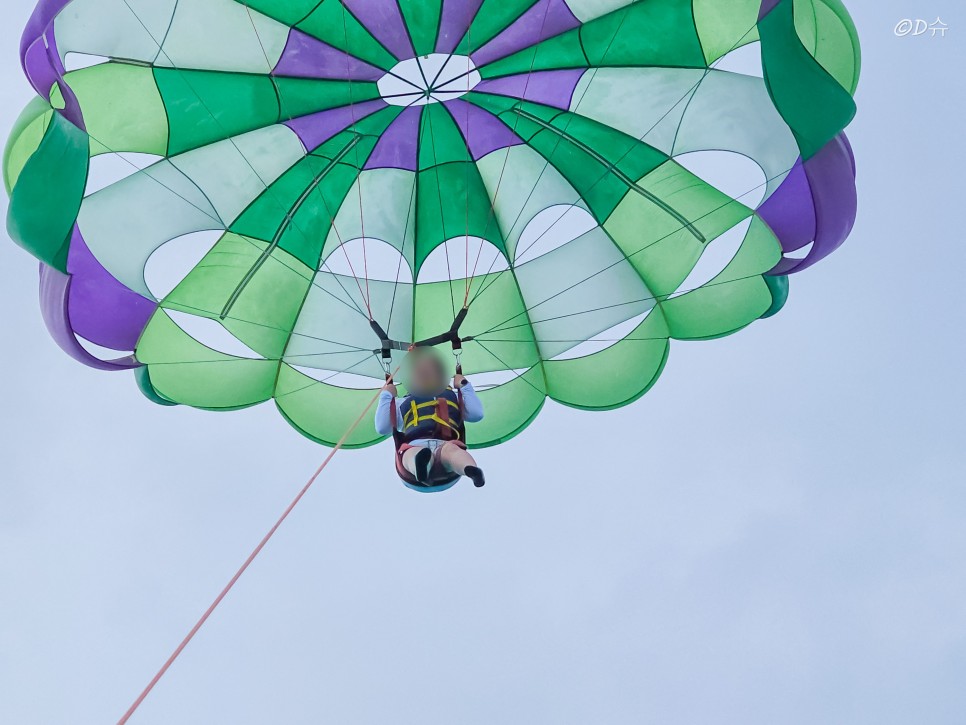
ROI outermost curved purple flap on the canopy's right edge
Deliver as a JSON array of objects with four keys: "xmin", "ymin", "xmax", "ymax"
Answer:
[{"xmin": 771, "ymin": 133, "xmax": 858, "ymax": 274}]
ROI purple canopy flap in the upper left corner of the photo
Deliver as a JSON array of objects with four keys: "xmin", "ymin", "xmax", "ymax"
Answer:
[{"xmin": 20, "ymin": 0, "xmax": 86, "ymax": 130}]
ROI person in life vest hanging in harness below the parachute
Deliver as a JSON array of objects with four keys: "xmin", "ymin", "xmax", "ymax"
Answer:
[{"xmin": 375, "ymin": 348, "xmax": 486, "ymax": 491}]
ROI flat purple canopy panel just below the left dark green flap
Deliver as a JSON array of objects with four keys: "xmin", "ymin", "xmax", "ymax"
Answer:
[{"xmin": 67, "ymin": 226, "xmax": 157, "ymax": 350}]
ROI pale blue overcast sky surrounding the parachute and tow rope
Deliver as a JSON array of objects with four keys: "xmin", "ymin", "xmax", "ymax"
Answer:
[{"xmin": 0, "ymin": 0, "xmax": 966, "ymax": 725}]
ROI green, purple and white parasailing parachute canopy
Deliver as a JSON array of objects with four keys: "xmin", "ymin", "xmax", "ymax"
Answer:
[{"xmin": 4, "ymin": 0, "xmax": 859, "ymax": 447}]
